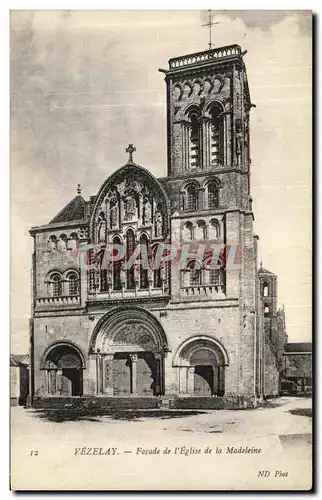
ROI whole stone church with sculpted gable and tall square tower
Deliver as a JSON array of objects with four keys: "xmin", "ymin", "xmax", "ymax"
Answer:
[{"xmin": 30, "ymin": 41, "xmax": 287, "ymax": 408}]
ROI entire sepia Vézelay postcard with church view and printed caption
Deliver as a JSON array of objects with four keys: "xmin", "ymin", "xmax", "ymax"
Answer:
[{"xmin": 10, "ymin": 10, "xmax": 312, "ymax": 491}]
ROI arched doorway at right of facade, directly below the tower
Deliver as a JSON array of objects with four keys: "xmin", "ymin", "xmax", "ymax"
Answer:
[{"xmin": 173, "ymin": 336, "xmax": 229, "ymax": 397}]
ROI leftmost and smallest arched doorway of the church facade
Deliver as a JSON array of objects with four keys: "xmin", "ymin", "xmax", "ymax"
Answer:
[{"xmin": 41, "ymin": 342, "xmax": 85, "ymax": 396}]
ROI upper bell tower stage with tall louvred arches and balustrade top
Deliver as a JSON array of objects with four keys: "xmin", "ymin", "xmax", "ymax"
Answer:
[{"xmin": 162, "ymin": 45, "xmax": 252, "ymax": 196}]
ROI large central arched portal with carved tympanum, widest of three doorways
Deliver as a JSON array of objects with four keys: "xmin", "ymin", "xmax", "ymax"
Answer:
[{"xmin": 90, "ymin": 307, "xmax": 167, "ymax": 396}]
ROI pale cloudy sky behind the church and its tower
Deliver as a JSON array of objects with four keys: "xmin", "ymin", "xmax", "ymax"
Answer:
[{"xmin": 10, "ymin": 10, "xmax": 312, "ymax": 353}]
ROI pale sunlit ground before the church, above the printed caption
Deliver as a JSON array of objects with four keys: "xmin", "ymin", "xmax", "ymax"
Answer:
[{"xmin": 11, "ymin": 397, "xmax": 312, "ymax": 438}]
